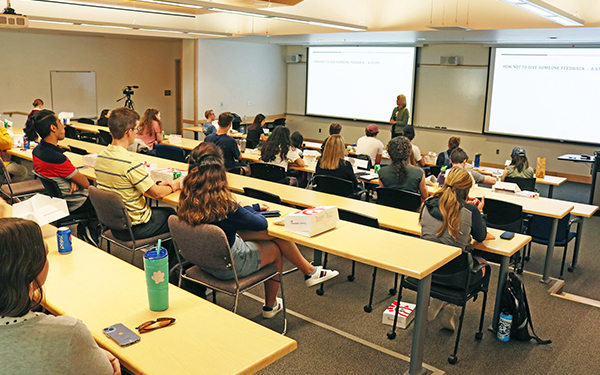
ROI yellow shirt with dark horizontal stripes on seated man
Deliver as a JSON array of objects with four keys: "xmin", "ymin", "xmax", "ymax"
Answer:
[{"xmin": 96, "ymin": 145, "xmax": 154, "ymax": 225}]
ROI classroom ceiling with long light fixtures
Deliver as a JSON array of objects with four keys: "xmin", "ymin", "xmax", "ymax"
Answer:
[{"xmin": 7, "ymin": 0, "xmax": 600, "ymax": 45}]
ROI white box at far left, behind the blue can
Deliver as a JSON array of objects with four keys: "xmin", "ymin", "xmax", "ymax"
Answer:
[{"xmin": 13, "ymin": 194, "xmax": 69, "ymax": 226}]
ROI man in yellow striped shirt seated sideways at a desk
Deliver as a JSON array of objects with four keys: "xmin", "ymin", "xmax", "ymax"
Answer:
[{"xmin": 95, "ymin": 108, "xmax": 180, "ymax": 241}]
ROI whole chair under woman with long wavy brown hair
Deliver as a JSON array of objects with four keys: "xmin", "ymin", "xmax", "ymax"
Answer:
[{"xmin": 169, "ymin": 215, "xmax": 287, "ymax": 335}]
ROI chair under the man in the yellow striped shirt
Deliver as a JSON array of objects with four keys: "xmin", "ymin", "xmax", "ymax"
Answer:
[{"xmin": 88, "ymin": 185, "xmax": 171, "ymax": 264}]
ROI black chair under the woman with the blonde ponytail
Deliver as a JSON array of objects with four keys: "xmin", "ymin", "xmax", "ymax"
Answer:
[{"xmin": 387, "ymin": 251, "xmax": 492, "ymax": 365}]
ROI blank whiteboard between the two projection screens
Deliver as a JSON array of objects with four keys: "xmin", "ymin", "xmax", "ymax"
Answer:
[{"xmin": 413, "ymin": 65, "xmax": 488, "ymax": 133}]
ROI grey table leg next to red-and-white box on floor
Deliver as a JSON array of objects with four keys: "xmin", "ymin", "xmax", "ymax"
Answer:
[{"xmin": 406, "ymin": 274, "xmax": 431, "ymax": 375}]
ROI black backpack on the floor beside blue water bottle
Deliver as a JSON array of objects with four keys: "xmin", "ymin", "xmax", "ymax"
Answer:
[{"xmin": 501, "ymin": 272, "xmax": 552, "ymax": 345}]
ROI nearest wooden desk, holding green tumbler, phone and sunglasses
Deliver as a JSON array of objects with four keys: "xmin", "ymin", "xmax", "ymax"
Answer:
[{"xmin": 44, "ymin": 228, "xmax": 297, "ymax": 375}]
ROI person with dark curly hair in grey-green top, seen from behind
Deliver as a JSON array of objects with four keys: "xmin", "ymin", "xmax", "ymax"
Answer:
[{"xmin": 379, "ymin": 135, "xmax": 429, "ymax": 199}]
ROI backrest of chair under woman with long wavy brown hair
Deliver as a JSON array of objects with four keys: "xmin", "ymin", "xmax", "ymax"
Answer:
[{"xmin": 169, "ymin": 215, "xmax": 233, "ymax": 271}]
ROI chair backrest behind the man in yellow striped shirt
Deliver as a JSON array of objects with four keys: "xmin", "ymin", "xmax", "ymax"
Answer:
[{"xmin": 88, "ymin": 185, "xmax": 131, "ymax": 230}]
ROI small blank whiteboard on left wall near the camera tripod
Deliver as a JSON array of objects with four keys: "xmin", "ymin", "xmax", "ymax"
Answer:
[{"xmin": 50, "ymin": 70, "xmax": 98, "ymax": 118}]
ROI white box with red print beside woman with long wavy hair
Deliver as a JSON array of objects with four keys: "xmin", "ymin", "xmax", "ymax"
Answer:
[{"xmin": 285, "ymin": 206, "xmax": 339, "ymax": 237}]
